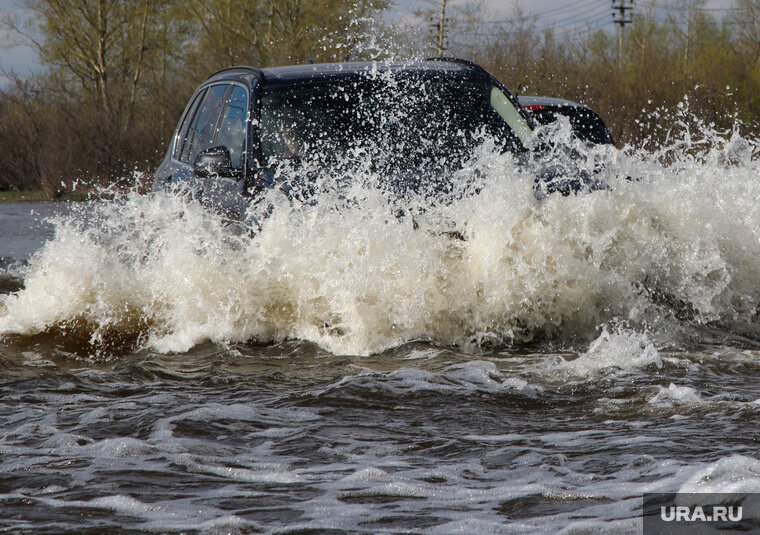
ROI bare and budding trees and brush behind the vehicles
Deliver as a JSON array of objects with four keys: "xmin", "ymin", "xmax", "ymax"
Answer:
[{"xmin": 0, "ymin": 0, "xmax": 760, "ymax": 193}]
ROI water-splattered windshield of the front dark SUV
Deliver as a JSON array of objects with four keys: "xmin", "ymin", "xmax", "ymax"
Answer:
[{"xmin": 261, "ymin": 74, "xmax": 531, "ymax": 171}]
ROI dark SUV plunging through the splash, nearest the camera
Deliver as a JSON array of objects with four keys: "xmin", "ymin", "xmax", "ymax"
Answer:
[{"xmin": 154, "ymin": 59, "xmax": 534, "ymax": 216}]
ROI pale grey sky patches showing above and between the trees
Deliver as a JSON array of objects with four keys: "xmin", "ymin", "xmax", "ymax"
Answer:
[{"xmin": 0, "ymin": 0, "xmax": 733, "ymax": 79}]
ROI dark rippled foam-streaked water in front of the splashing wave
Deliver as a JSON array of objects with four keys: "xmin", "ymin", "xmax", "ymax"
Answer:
[{"xmin": 0, "ymin": 334, "xmax": 760, "ymax": 533}]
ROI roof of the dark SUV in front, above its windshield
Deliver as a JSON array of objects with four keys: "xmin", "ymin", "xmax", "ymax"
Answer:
[{"xmin": 209, "ymin": 58, "xmax": 487, "ymax": 86}]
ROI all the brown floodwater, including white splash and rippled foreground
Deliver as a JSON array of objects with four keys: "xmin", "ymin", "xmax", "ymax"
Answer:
[{"xmin": 0, "ymin": 124, "xmax": 760, "ymax": 534}]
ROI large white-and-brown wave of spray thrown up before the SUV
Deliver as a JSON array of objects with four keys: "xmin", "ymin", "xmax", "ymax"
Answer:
[{"xmin": 0, "ymin": 119, "xmax": 760, "ymax": 354}]
